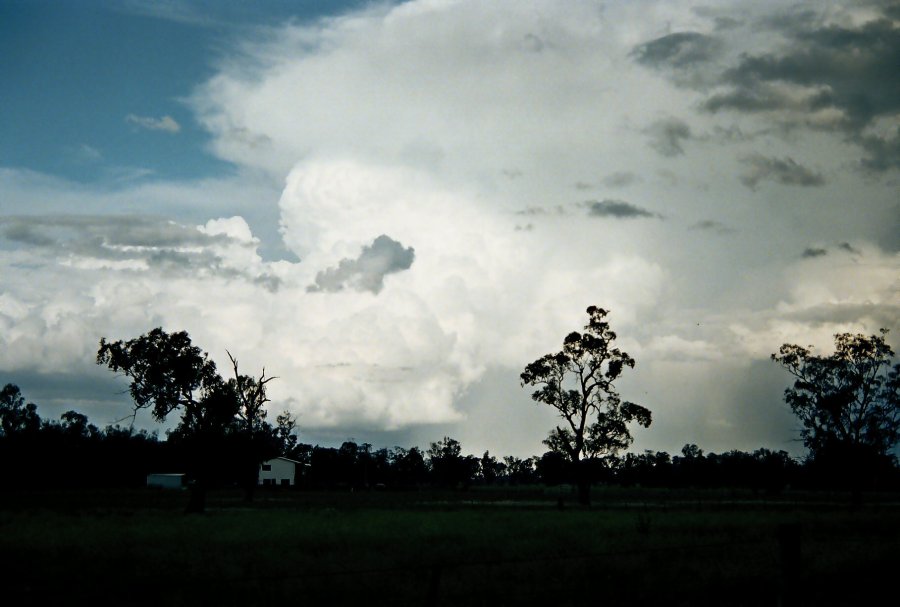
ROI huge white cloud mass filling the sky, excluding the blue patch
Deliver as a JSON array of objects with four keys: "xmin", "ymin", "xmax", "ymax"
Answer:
[{"xmin": 0, "ymin": 0, "xmax": 900, "ymax": 454}]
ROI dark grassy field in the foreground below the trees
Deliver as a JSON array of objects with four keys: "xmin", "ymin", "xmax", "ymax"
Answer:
[{"xmin": 0, "ymin": 487, "xmax": 900, "ymax": 606}]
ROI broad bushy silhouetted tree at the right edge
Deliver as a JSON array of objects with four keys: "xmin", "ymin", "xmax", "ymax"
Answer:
[{"xmin": 772, "ymin": 329, "xmax": 900, "ymax": 489}]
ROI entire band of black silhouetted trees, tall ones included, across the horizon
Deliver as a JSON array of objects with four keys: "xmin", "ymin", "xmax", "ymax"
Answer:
[{"xmin": 0, "ymin": 316, "xmax": 900, "ymax": 502}]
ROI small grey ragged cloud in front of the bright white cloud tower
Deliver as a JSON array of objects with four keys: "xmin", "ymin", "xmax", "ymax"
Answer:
[{"xmin": 307, "ymin": 234, "xmax": 416, "ymax": 293}]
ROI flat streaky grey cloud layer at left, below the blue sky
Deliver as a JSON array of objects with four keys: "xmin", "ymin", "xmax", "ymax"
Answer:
[{"xmin": 0, "ymin": 215, "xmax": 279, "ymax": 290}]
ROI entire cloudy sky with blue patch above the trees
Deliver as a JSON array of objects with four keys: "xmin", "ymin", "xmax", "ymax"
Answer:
[{"xmin": 0, "ymin": 0, "xmax": 900, "ymax": 457}]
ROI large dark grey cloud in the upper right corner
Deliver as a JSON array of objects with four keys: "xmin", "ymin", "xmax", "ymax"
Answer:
[{"xmin": 703, "ymin": 12, "xmax": 900, "ymax": 172}]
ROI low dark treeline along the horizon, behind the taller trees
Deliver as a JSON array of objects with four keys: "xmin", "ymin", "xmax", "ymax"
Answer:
[{"xmin": 0, "ymin": 384, "xmax": 900, "ymax": 495}]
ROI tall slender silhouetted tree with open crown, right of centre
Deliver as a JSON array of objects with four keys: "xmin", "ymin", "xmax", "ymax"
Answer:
[{"xmin": 520, "ymin": 306, "xmax": 651, "ymax": 504}]
